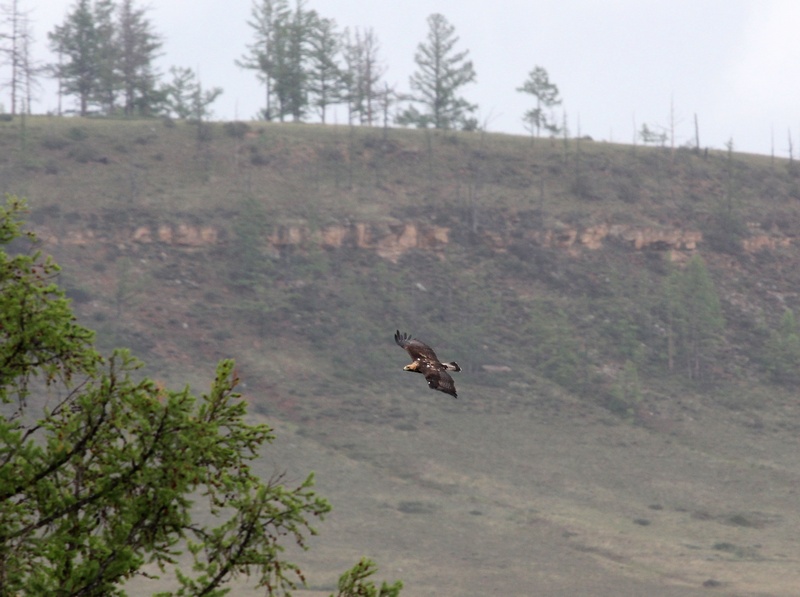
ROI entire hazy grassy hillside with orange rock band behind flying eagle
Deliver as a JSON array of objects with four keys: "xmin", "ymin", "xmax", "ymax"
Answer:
[{"xmin": 0, "ymin": 117, "xmax": 800, "ymax": 595}]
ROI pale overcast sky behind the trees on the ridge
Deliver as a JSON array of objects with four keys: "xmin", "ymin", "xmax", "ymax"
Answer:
[{"xmin": 21, "ymin": 0, "xmax": 800, "ymax": 156}]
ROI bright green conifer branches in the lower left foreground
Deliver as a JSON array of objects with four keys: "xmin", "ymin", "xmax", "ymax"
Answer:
[{"xmin": 0, "ymin": 197, "xmax": 400, "ymax": 596}]
